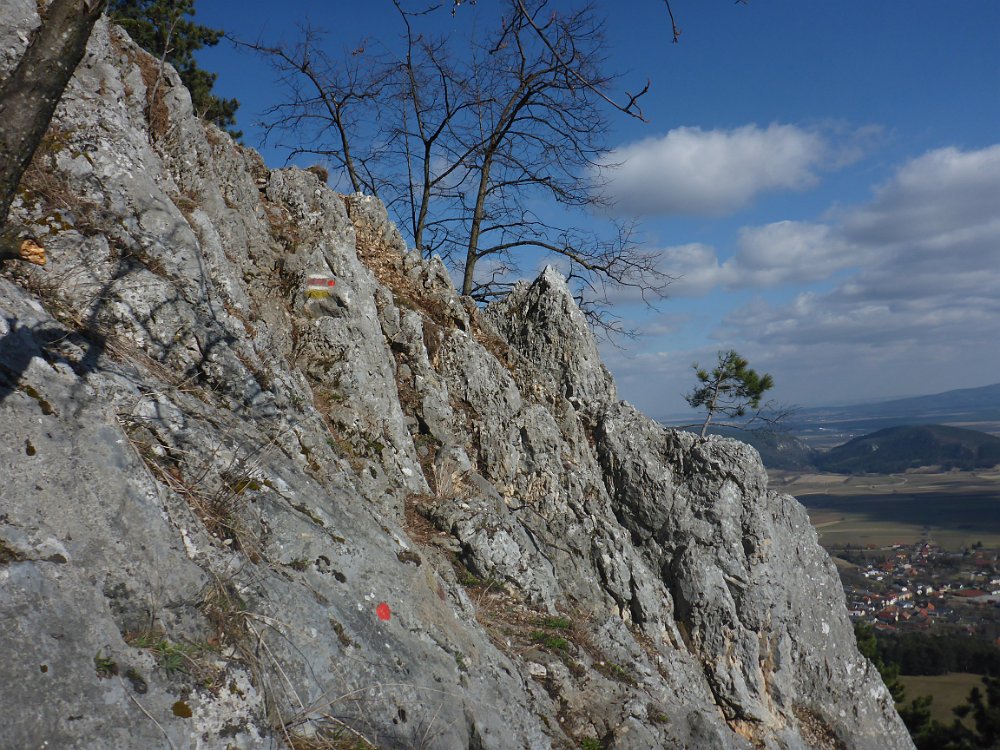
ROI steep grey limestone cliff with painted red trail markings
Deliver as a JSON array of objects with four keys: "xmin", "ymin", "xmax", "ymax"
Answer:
[{"xmin": 0, "ymin": 7, "xmax": 911, "ymax": 750}]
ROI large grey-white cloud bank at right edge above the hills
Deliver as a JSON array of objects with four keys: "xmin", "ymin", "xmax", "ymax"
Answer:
[{"xmin": 721, "ymin": 145, "xmax": 1000, "ymax": 408}]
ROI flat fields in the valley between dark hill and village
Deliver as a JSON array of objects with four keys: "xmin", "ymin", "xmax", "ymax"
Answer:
[{"xmin": 771, "ymin": 469, "xmax": 1000, "ymax": 550}]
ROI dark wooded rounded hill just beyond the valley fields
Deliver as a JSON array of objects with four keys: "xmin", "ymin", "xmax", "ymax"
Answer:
[{"xmin": 813, "ymin": 425, "xmax": 1000, "ymax": 474}]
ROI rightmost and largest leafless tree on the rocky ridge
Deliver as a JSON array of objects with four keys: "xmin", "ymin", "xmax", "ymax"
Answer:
[{"xmin": 462, "ymin": 0, "xmax": 669, "ymax": 308}]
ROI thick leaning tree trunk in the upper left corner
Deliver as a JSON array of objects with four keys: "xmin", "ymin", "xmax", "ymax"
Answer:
[{"xmin": 0, "ymin": 0, "xmax": 106, "ymax": 235}]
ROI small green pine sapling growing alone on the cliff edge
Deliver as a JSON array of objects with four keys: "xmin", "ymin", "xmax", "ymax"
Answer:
[{"xmin": 684, "ymin": 349, "xmax": 774, "ymax": 437}]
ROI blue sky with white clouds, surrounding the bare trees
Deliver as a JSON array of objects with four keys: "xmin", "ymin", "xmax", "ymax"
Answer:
[{"xmin": 191, "ymin": 0, "xmax": 1000, "ymax": 416}]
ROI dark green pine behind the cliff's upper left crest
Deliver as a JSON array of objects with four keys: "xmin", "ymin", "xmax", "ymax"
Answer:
[{"xmin": 109, "ymin": 0, "xmax": 243, "ymax": 138}]
